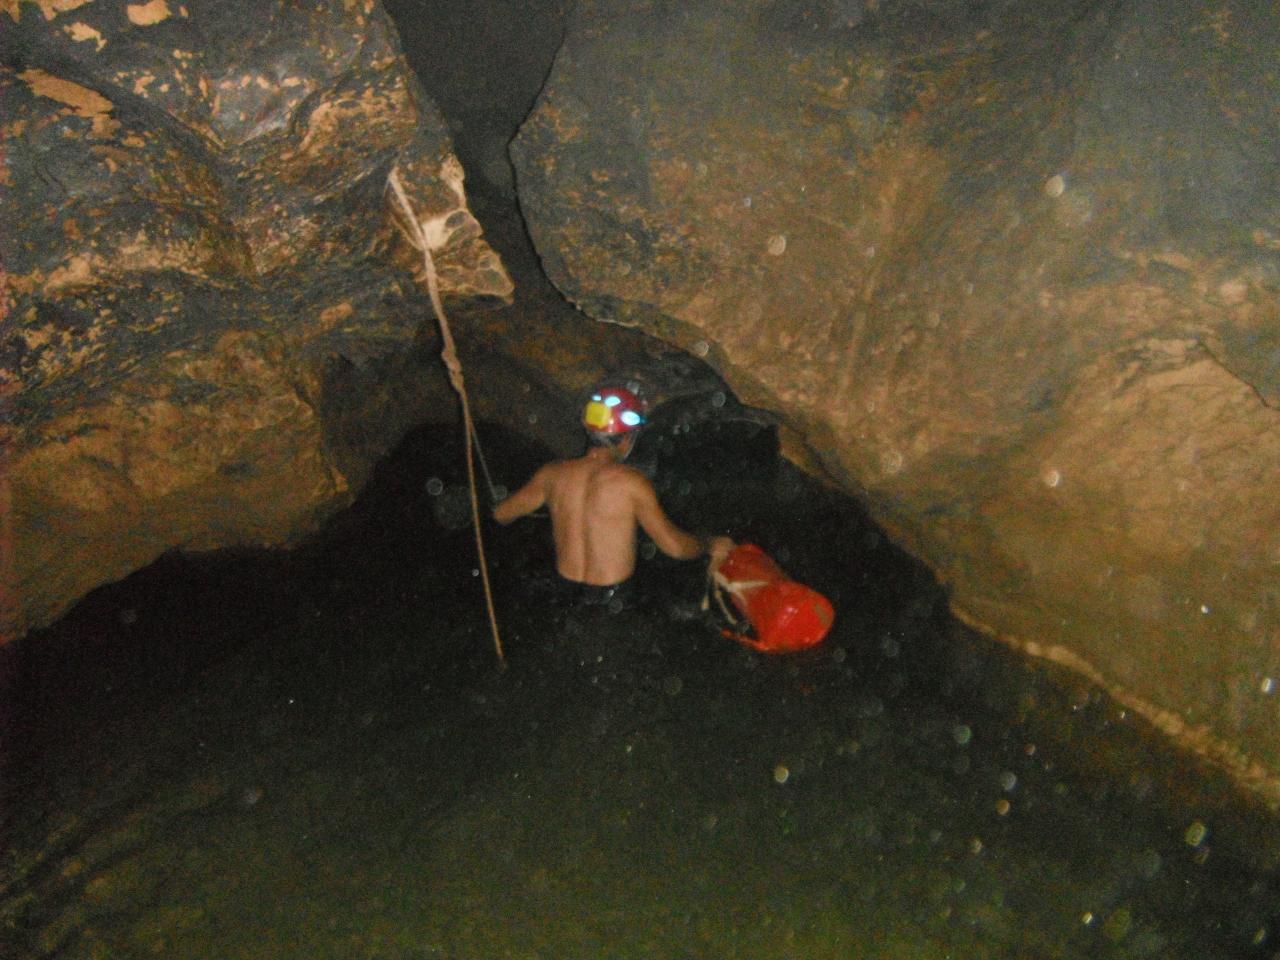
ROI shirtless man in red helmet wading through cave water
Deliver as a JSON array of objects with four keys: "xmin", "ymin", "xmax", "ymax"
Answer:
[{"xmin": 493, "ymin": 387, "xmax": 733, "ymax": 603}]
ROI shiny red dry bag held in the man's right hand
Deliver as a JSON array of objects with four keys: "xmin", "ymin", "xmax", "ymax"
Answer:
[{"xmin": 714, "ymin": 543, "xmax": 836, "ymax": 653}]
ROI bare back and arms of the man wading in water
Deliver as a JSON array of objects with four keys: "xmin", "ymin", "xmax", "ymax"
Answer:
[{"xmin": 494, "ymin": 447, "xmax": 733, "ymax": 586}]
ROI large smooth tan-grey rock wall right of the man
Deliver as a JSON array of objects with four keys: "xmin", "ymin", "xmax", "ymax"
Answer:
[{"xmin": 513, "ymin": 0, "xmax": 1280, "ymax": 803}]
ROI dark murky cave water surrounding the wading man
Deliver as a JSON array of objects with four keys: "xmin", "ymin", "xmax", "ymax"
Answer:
[{"xmin": 0, "ymin": 424, "xmax": 1280, "ymax": 960}]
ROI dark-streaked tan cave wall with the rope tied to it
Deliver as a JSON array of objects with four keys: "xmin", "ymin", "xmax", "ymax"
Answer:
[{"xmin": 0, "ymin": 0, "xmax": 512, "ymax": 639}]
